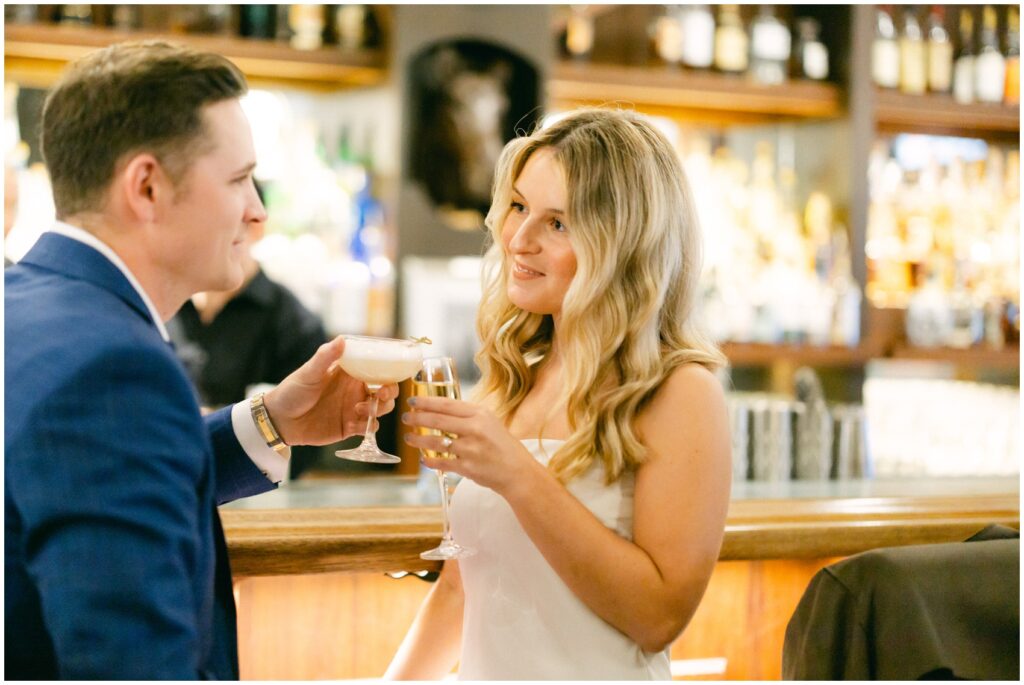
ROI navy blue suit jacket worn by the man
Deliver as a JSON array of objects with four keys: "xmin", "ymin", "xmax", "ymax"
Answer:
[{"xmin": 4, "ymin": 232, "xmax": 273, "ymax": 680}]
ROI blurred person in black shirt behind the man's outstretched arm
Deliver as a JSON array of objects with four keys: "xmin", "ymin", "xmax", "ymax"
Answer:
[{"xmin": 167, "ymin": 182, "xmax": 328, "ymax": 478}]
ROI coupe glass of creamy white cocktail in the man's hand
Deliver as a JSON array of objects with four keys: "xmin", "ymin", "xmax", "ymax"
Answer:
[{"xmin": 334, "ymin": 336, "xmax": 423, "ymax": 464}]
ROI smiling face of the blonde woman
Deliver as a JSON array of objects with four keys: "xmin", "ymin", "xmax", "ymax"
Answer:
[{"xmin": 502, "ymin": 147, "xmax": 577, "ymax": 317}]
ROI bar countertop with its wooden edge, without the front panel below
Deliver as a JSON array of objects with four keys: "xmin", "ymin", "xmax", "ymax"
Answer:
[{"xmin": 221, "ymin": 476, "xmax": 1020, "ymax": 576}]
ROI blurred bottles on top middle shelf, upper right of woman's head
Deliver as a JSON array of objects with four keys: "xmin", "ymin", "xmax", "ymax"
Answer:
[{"xmin": 564, "ymin": 4, "xmax": 829, "ymax": 85}]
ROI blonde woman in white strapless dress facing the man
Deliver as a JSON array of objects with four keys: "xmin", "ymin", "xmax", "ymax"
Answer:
[{"xmin": 386, "ymin": 110, "xmax": 730, "ymax": 680}]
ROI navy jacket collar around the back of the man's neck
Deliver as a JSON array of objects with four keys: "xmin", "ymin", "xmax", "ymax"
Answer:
[{"xmin": 19, "ymin": 231, "xmax": 156, "ymax": 326}]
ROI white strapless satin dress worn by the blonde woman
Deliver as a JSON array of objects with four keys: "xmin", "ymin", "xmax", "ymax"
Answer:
[{"xmin": 452, "ymin": 438, "xmax": 672, "ymax": 680}]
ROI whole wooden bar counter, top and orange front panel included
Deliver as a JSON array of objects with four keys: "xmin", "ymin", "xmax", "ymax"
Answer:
[{"xmin": 221, "ymin": 476, "xmax": 1020, "ymax": 680}]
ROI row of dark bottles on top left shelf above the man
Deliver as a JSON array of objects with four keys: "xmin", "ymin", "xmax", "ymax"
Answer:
[{"xmin": 4, "ymin": 4, "xmax": 381, "ymax": 50}]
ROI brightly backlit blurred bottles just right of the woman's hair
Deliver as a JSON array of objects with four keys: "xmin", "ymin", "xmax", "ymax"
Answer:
[{"xmin": 684, "ymin": 138, "xmax": 861, "ymax": 346}]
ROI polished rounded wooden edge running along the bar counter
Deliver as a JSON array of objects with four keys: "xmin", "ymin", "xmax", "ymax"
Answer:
[{"xmin": 221, "ymin": 481, "xmax": 1020, "ymax": 577}]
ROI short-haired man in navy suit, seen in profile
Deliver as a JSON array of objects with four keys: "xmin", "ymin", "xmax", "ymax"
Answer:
[{"xmin": 4, "ymin": 43, "xmax": 397, "ymax": 680}]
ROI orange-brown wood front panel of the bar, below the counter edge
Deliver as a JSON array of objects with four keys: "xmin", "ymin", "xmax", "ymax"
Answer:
[{"xmin": 236, "ymin": 559, "xmax": 835, "ymax": 680}]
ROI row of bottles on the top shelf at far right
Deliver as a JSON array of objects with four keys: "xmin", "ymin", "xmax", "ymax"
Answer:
[{"xmin": 871, "ymin": 5, "xmax": 1020, "ymax": 104}]
